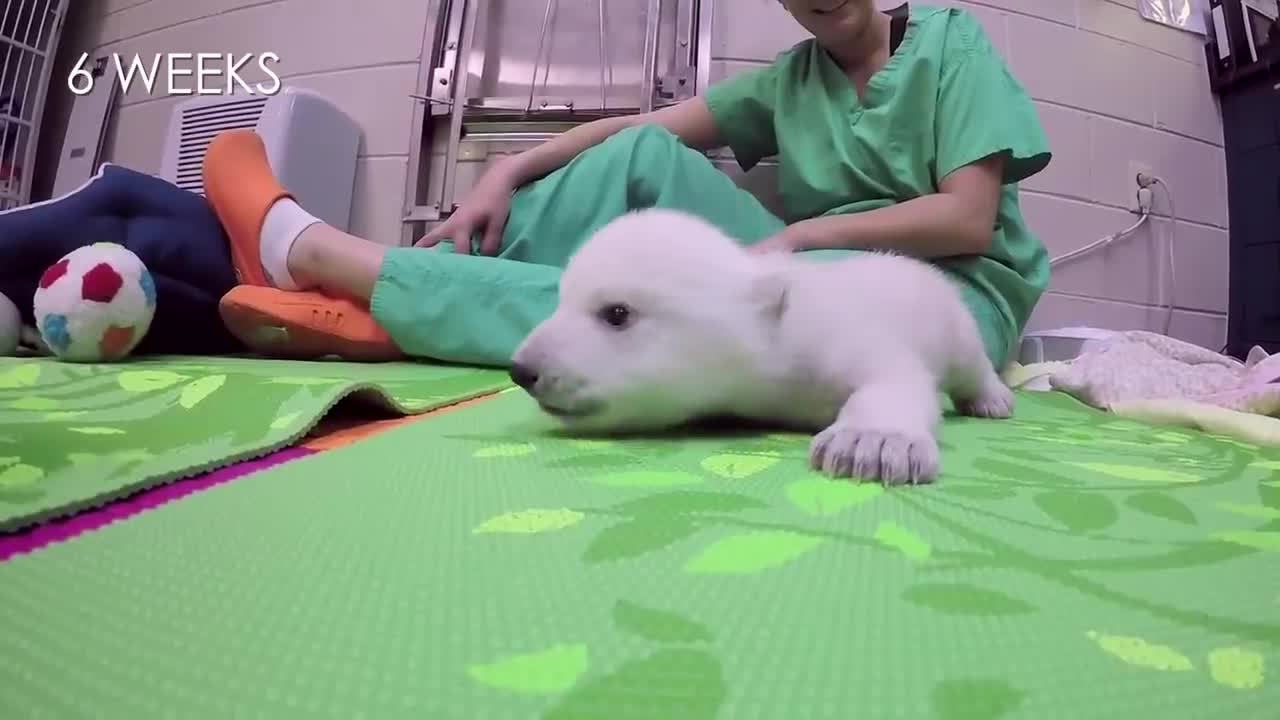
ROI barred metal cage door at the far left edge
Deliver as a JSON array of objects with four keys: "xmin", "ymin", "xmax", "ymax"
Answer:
[{"xmin": 0, "ymin": 0, "xmax": 67, "ymax": 210}]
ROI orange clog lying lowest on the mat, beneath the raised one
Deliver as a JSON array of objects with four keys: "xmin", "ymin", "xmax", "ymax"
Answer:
[{"xmin": 218, "ymin": 284, "xmax": 404, "ymax": 363}]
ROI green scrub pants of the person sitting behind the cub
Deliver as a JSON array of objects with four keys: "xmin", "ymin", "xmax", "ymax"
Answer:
[{"xmin": 370, "ymin": 124, "xmax": 1006, "ymax": 368}]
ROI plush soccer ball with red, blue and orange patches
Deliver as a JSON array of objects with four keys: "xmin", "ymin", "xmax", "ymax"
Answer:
[{"xmin": 33, "ymin": 242, "xmax": 156, "ymax": 363}]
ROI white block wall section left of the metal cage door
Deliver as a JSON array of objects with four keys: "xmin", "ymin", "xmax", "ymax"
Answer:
[{"xmin": 61, "ymin": 0, "xmax": 428, "ymax": 243}]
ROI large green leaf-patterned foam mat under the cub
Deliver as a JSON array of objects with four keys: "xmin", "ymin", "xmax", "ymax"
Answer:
[{"xmin": 0, "ymin": 384, "xmax": 1280, "ymax": 720}]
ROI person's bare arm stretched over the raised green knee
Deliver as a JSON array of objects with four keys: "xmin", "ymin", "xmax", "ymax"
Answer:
[{"xmin": 490, "ymin": 96, "xmax": 722, "ymax": 187}]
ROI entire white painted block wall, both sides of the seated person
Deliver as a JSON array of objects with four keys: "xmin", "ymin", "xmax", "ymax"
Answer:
[{"xmin": 52, "ymin": 0, "xmax": 1228, "ymax": 350}]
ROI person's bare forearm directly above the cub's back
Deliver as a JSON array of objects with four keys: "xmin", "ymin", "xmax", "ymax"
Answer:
[{"xmin": 762, "ymin": 154, "xmax": 1005, "ymax": 259}]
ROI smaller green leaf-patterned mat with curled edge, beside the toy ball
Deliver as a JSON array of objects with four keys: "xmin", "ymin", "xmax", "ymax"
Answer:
[{"xmin": 0, "ymin": 357, "xmax": 511, "ymax": 530}]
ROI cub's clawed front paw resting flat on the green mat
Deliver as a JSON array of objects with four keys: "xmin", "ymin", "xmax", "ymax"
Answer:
[{"xmin": 809, "ymin": 423, "xmax": 938, "ymax": 486}]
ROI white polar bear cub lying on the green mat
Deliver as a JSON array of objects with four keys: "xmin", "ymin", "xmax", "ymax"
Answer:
[{"xmin": 511, "ymin": 209, "xmax": 1014, "ymax": 484}]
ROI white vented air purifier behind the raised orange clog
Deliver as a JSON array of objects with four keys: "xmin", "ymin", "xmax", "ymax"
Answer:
[{"xmin": 160, "ymin": 87, "xmax": 360, "ymax": 232}]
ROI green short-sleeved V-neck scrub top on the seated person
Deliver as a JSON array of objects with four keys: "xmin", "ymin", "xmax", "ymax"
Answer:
[{"xmin": 704, "ymin": 4, "xmax": 1051, "ymax": 353}]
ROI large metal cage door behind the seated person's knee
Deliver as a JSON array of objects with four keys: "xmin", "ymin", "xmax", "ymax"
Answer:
[{"xmin": 404, "ymin": 0, "xmax": 712, "ymax": 238}]
